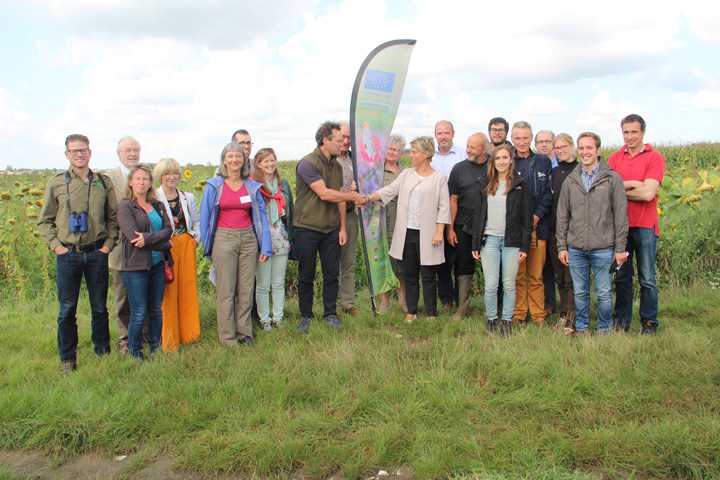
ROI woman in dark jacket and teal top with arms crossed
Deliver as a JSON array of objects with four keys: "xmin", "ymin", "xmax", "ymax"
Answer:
[{"xmin": 117, "ymin": 163, "xmax": 173, "ymax": 360}]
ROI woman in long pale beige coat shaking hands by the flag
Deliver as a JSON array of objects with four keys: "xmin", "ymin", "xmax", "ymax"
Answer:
[{"xmin": 364, "ymin": 137, "xmax": 450, "ymax": 323}]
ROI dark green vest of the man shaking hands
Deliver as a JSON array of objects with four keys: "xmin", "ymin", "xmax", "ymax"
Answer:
[{"xmin": 293, "ymin": 147, "xmax": 342, "ymax": 233}]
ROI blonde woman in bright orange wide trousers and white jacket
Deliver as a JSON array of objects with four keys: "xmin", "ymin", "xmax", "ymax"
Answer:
[{"xmin": 154, "ymin": 158, "xmax": 200, "ymax": 352}]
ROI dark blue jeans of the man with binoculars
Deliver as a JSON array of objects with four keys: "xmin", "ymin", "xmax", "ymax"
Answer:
[{"xmin": 56, "ymin": 250, "xmax": 110, "ymax": 362}]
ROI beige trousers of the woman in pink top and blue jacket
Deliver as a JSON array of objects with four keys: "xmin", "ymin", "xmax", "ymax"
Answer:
[{"xmin": 212, "ymin": 227, "xmax": 258, "ymax": 346}]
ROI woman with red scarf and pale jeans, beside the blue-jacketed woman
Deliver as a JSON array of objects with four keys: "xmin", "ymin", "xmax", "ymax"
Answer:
[{"xmin": 253, "ymin": 148, "xmax": 294, "ymax": 332}]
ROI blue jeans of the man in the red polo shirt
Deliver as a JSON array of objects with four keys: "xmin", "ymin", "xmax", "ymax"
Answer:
[{"xmin": 615, "ymin": 227, "xmax": 658, "ymax": 327}]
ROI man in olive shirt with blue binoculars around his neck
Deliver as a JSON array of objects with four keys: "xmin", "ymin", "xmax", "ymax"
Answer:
[{"xmin": 38, "ymin": 134, "xmax": 118, "ymax": 375}]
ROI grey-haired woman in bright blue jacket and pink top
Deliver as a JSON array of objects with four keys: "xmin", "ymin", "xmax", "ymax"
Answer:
[{"xmin": 200, "ymin": 143, "xmax": 272, "ymax": 347}]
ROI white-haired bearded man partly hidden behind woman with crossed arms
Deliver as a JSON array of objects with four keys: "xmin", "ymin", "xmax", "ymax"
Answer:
[{"xmin": 105, "ymin": 136, "xmax": 147, "ymax": 355}]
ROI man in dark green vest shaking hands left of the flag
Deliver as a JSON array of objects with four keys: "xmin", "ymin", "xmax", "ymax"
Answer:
[{"xmin": 293, "ymin": 121, "xmax": 360, "ymax": 333}]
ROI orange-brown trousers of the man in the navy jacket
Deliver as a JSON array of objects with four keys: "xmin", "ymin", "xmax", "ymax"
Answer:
[{"xmin": 513, "ymin": 230, "xmax": 546, "ymax": 323}]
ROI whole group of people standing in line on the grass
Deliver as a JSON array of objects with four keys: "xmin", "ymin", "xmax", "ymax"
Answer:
[{"xmin": 38, "ymin": 114, "xmax": 664, "ymax": 374}]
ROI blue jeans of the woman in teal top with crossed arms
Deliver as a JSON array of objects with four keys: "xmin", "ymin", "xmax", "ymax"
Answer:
[{"xmin": 123, "ymin": 262, "xmax": 165, "ymax": 358}]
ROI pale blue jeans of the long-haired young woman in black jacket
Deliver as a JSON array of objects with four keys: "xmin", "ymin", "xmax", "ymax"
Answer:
[{"xmin": 480, "ymin": 235, "xmax": 520, "ymax": 322}]
